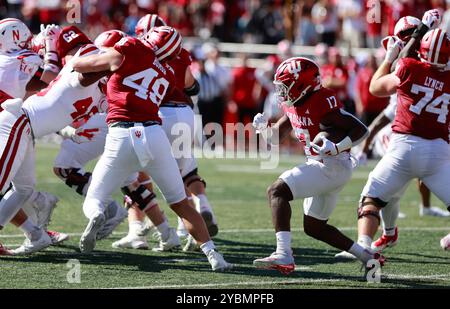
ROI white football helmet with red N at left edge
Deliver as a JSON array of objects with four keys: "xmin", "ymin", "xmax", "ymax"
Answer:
[{"xmin": 0, "ymin": 18, "xmax": 33, "ymax": 53}]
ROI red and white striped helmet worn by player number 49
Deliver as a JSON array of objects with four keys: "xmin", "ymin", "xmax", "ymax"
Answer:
[{"xmin": 144, "ymin": 26, "xmax": 182, "ymax": 61}]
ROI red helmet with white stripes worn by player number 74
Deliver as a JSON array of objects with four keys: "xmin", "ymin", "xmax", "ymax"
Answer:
[{"xmin": 419, "ymin": 29, "xmax": 450, "ymax": 67}]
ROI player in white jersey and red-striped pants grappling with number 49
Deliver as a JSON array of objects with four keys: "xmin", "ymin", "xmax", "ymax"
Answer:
[{"xmin": 0, "ymin": 26, "xmax": 110, "ymax": 254}]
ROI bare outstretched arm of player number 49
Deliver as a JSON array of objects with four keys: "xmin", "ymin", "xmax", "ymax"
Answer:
[{"xmin": 73, "ymin": 48, "xmax": 124, "ymax": 73}]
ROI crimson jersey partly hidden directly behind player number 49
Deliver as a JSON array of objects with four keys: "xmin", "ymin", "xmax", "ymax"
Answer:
[{"xmin": 162, "ymin": 48, "xmax": 192, "ymax": 104}]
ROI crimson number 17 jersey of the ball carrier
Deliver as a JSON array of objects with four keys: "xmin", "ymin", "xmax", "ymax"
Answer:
[{"xmin": 282, "ymin": 88, "xmax": 343, "ymax": 156}]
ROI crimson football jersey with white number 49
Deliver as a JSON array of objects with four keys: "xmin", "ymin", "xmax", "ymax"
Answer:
[{"xmin": 106, "ymin": 37, "xmax": 175, "ymax": 123}]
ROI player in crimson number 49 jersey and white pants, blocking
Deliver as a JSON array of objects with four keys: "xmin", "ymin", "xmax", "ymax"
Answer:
[{"xmin": 74, "ymin": 27, "xmax": 232, "ymax": 271}]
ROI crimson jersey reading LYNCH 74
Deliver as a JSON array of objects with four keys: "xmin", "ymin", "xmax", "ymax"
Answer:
[{"xmin": 392, "ymin": 58, "xmax": 450, "ymax": 142}]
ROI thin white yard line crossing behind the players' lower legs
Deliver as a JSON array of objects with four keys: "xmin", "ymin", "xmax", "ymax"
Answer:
[{"xmin": 0, "ymin": 226, "xmax": 450, "ymax": 239}]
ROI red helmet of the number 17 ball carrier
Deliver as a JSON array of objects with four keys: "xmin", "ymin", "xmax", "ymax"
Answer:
[{"xmin": 273, "ymin": 57, "xmax": 322, "ymax": 106}]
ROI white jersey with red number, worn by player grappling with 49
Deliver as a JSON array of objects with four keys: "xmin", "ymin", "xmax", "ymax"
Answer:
[{"xmin": 23, "ymin": 44, "xmax": 104, "ymax": 138}]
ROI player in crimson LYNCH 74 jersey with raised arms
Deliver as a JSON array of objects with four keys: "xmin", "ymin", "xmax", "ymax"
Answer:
[{"xmin": 358, "ymin": 21, "xmax": 450, "ymax": 256}]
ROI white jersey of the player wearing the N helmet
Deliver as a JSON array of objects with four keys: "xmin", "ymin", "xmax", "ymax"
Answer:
[{"xmin": 0, "ymin": 49, "xmax": 42, "ymax": 99}]
